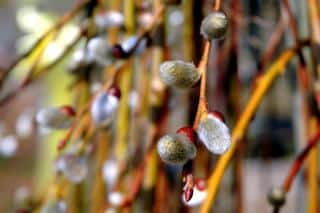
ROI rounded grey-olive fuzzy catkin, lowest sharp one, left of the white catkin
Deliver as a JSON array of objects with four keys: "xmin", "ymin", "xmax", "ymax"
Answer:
[{"xmin": 157, "ymin": 134, "xmax": 197, "ymax": 165}]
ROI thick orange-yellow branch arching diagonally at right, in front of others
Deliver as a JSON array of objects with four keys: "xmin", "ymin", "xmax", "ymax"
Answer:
[{"xmin": 201, "ymin": 44, "xmax": 306, "ymax": 213}]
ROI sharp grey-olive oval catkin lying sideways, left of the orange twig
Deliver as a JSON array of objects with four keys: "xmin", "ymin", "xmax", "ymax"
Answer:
[{"xmin": 160, "ymin": 60, "xmax": 201, "ymax": 89}]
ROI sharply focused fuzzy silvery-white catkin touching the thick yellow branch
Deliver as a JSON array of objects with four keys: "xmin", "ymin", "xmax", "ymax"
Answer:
[{"xmin": 197, "ymin": 114, "xmax": 231, "ymax": 154}]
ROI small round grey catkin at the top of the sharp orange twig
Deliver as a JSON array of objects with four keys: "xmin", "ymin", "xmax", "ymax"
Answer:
[{"xmin": 200, "ymin": 11, "xmax": 228, "ymax": 40}]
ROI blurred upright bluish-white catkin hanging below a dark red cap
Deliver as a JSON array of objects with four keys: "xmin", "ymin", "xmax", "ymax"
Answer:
[{"xmin": 91, "ymin": 92, "xmax": 119, "ymax": 127}]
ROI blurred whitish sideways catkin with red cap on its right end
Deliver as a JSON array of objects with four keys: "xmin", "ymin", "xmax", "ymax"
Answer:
[{"xmin": 36, "ymin": 106, "xmax": 75, "ymax": 129}]
